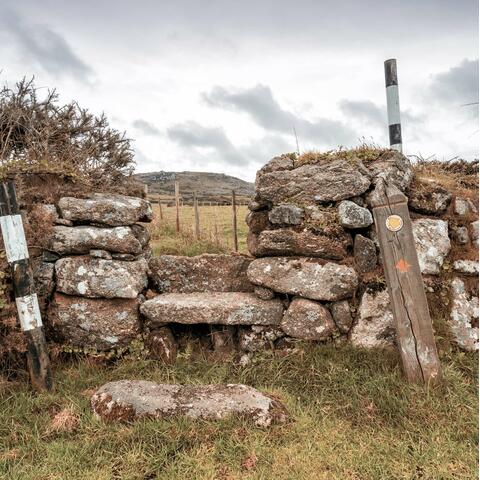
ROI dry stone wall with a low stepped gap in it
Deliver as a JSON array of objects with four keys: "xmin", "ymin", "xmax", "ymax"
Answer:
[{"xmin": 18, "ymin": 151, "xmax": 478, "ymax": 362}]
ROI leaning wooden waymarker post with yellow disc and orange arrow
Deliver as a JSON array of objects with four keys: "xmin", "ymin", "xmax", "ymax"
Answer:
[{"xmin": 371, "ymin": 179, "xmax": 441, "ymax": 384}]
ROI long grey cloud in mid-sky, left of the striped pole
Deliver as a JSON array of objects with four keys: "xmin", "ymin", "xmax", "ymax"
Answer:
[{"xmin": 202, "ymin": 85, "xmax": 356, "ymax": 147}]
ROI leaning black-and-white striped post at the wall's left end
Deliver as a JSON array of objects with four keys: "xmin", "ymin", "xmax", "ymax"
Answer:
[{"xmin": 0, "ymin": 181, "xmax": 53, "ymax": 390}]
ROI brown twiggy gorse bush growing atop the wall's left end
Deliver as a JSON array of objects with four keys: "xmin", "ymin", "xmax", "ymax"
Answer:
[{"xmin": 0, "ymin": 79, "xmax": 134, "ymax": 200}]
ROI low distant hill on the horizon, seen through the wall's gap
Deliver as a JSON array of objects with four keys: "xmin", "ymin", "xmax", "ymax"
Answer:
[{"xmin": 135, "ymin": 171, "xmax": 254, "ymax": 201}]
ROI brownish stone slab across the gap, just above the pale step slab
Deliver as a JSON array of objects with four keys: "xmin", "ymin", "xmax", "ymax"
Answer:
[{"xmin": 148, "ymin": 254, "xmax": 253, "ymax": 293}]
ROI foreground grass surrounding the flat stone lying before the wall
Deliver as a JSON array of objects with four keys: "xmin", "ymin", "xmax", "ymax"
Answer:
[{"xmin": 0, "ymin": 344, "xmax": 478, "ymax": 480}]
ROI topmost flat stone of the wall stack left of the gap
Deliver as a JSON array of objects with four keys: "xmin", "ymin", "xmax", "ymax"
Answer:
[{"xmin": 58, "ymin": 193, "xmax": 153, "ymax": 227}]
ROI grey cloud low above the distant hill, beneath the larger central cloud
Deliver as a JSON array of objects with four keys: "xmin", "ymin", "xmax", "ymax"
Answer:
[{"xmin": 167, "ymin": 121, "xmax": 248, "ymax": 165}]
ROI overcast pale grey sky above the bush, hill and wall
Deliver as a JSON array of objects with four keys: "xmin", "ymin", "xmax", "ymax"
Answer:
[{"xmin": 0, "ymin": 0, "xmax": 478, "ymax": 180}]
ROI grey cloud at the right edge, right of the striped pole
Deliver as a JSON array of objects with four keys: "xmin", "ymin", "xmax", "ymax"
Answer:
[{"xmin": 430, "ymin": 58, "xmax": 478, "ymax": 106}]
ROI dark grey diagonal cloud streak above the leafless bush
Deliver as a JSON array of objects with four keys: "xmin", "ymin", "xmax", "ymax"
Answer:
[{"xmin": 0, "ymin": 10, "xmax": 92, "ymax": 81}]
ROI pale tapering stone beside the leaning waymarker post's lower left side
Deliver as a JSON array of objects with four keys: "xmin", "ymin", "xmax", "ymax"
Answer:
[{"xmin": 350, "ymin": 290, "xmax": 395, "ymax": 348}]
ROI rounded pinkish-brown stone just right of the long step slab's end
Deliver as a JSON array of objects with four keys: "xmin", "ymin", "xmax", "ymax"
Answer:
[{"xmin": 280, "ymin": 297, "xmax": 337, "ymax": 340}]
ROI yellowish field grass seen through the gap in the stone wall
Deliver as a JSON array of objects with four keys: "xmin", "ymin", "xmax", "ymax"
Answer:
[{"xmin": 148, "ymin": 205, "xmax": 248, "ymax": 256}]
